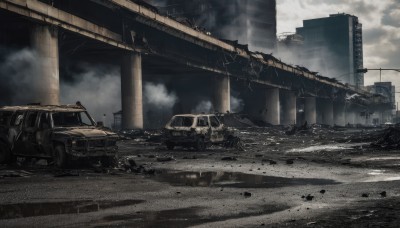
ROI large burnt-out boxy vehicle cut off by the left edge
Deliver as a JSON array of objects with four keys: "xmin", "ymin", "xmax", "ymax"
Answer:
[{"xmin": 0, "ymin": 104, "xmax": 118, "ymax": 167}]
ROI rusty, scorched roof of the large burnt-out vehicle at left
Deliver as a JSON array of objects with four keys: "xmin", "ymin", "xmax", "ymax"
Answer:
[{"xmin": 0, "ymin": 105, "xmax": 86, "ymax": 112}]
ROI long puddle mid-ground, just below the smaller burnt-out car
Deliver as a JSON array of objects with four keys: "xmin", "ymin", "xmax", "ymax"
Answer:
[{"xmin": 150, "ymin": 171, "xmax": 338, "ymax": 188}]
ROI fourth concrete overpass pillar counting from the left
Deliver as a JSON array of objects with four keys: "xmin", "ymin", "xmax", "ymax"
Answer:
[{"xmin": 262, "ymin": 88, "xmax": 280, "ymax": 125}]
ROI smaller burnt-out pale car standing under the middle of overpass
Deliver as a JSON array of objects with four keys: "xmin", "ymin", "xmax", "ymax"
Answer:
[{"xmin": 164, "ymin": 114, "xmax": 233, "ymax": 151}]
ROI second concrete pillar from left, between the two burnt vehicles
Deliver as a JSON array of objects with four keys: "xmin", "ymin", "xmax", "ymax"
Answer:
[{"xmin": 121, "ymin": 53, "xmax": 143, "ymax": 129}]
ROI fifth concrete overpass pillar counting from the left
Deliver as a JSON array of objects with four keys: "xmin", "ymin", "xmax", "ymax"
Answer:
[{"xmin": 280, "ymin": 91, "xmax": 296, "ymax": 125}]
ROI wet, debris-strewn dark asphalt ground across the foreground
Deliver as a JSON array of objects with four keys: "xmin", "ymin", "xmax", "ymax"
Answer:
[{"xmin": 0, "ymin": 128, "xmax": 400, "ymax": 227}]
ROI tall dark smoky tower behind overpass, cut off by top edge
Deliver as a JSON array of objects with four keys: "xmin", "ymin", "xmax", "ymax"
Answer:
[{"xmin": 149, "ymin": 0, "xmax": 276, "ymax": 53}]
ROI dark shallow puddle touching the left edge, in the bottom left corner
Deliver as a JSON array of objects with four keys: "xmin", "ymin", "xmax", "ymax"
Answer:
[{"xmin": 0, "ymin": 200, "xmax": 144, "ymax": 219}]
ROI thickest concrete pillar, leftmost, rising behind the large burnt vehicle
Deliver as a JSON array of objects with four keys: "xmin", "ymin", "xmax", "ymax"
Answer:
[{"xmin": 31, "ymin": 24, "xmax": 60, "ymax": 105}]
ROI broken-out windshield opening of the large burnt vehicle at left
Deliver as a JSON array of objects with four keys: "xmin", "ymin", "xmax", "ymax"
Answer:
[{"xmin": 52, "ymin": 112, "xmax": 93, "ymax": 127}]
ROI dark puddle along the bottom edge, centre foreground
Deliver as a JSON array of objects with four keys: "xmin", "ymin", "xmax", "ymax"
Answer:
[{"xmin": 95, "ymin": 205, "xmax": 290, "ymax": 227}]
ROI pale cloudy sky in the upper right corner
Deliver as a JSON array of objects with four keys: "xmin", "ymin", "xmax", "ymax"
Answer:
[{"xmin": 277, "ymin": 0, "xmax": 400, "ymax": 98}]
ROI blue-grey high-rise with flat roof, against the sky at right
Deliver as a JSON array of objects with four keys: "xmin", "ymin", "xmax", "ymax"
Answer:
[{"xmin": 296, "ymin": 14, "xmax": 364, "ymax": 87}]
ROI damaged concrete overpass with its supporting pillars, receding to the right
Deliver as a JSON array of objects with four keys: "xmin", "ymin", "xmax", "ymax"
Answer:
[{"xmin": 0, "ymin": 0, "xmax": 390, "ymax": 128}]
